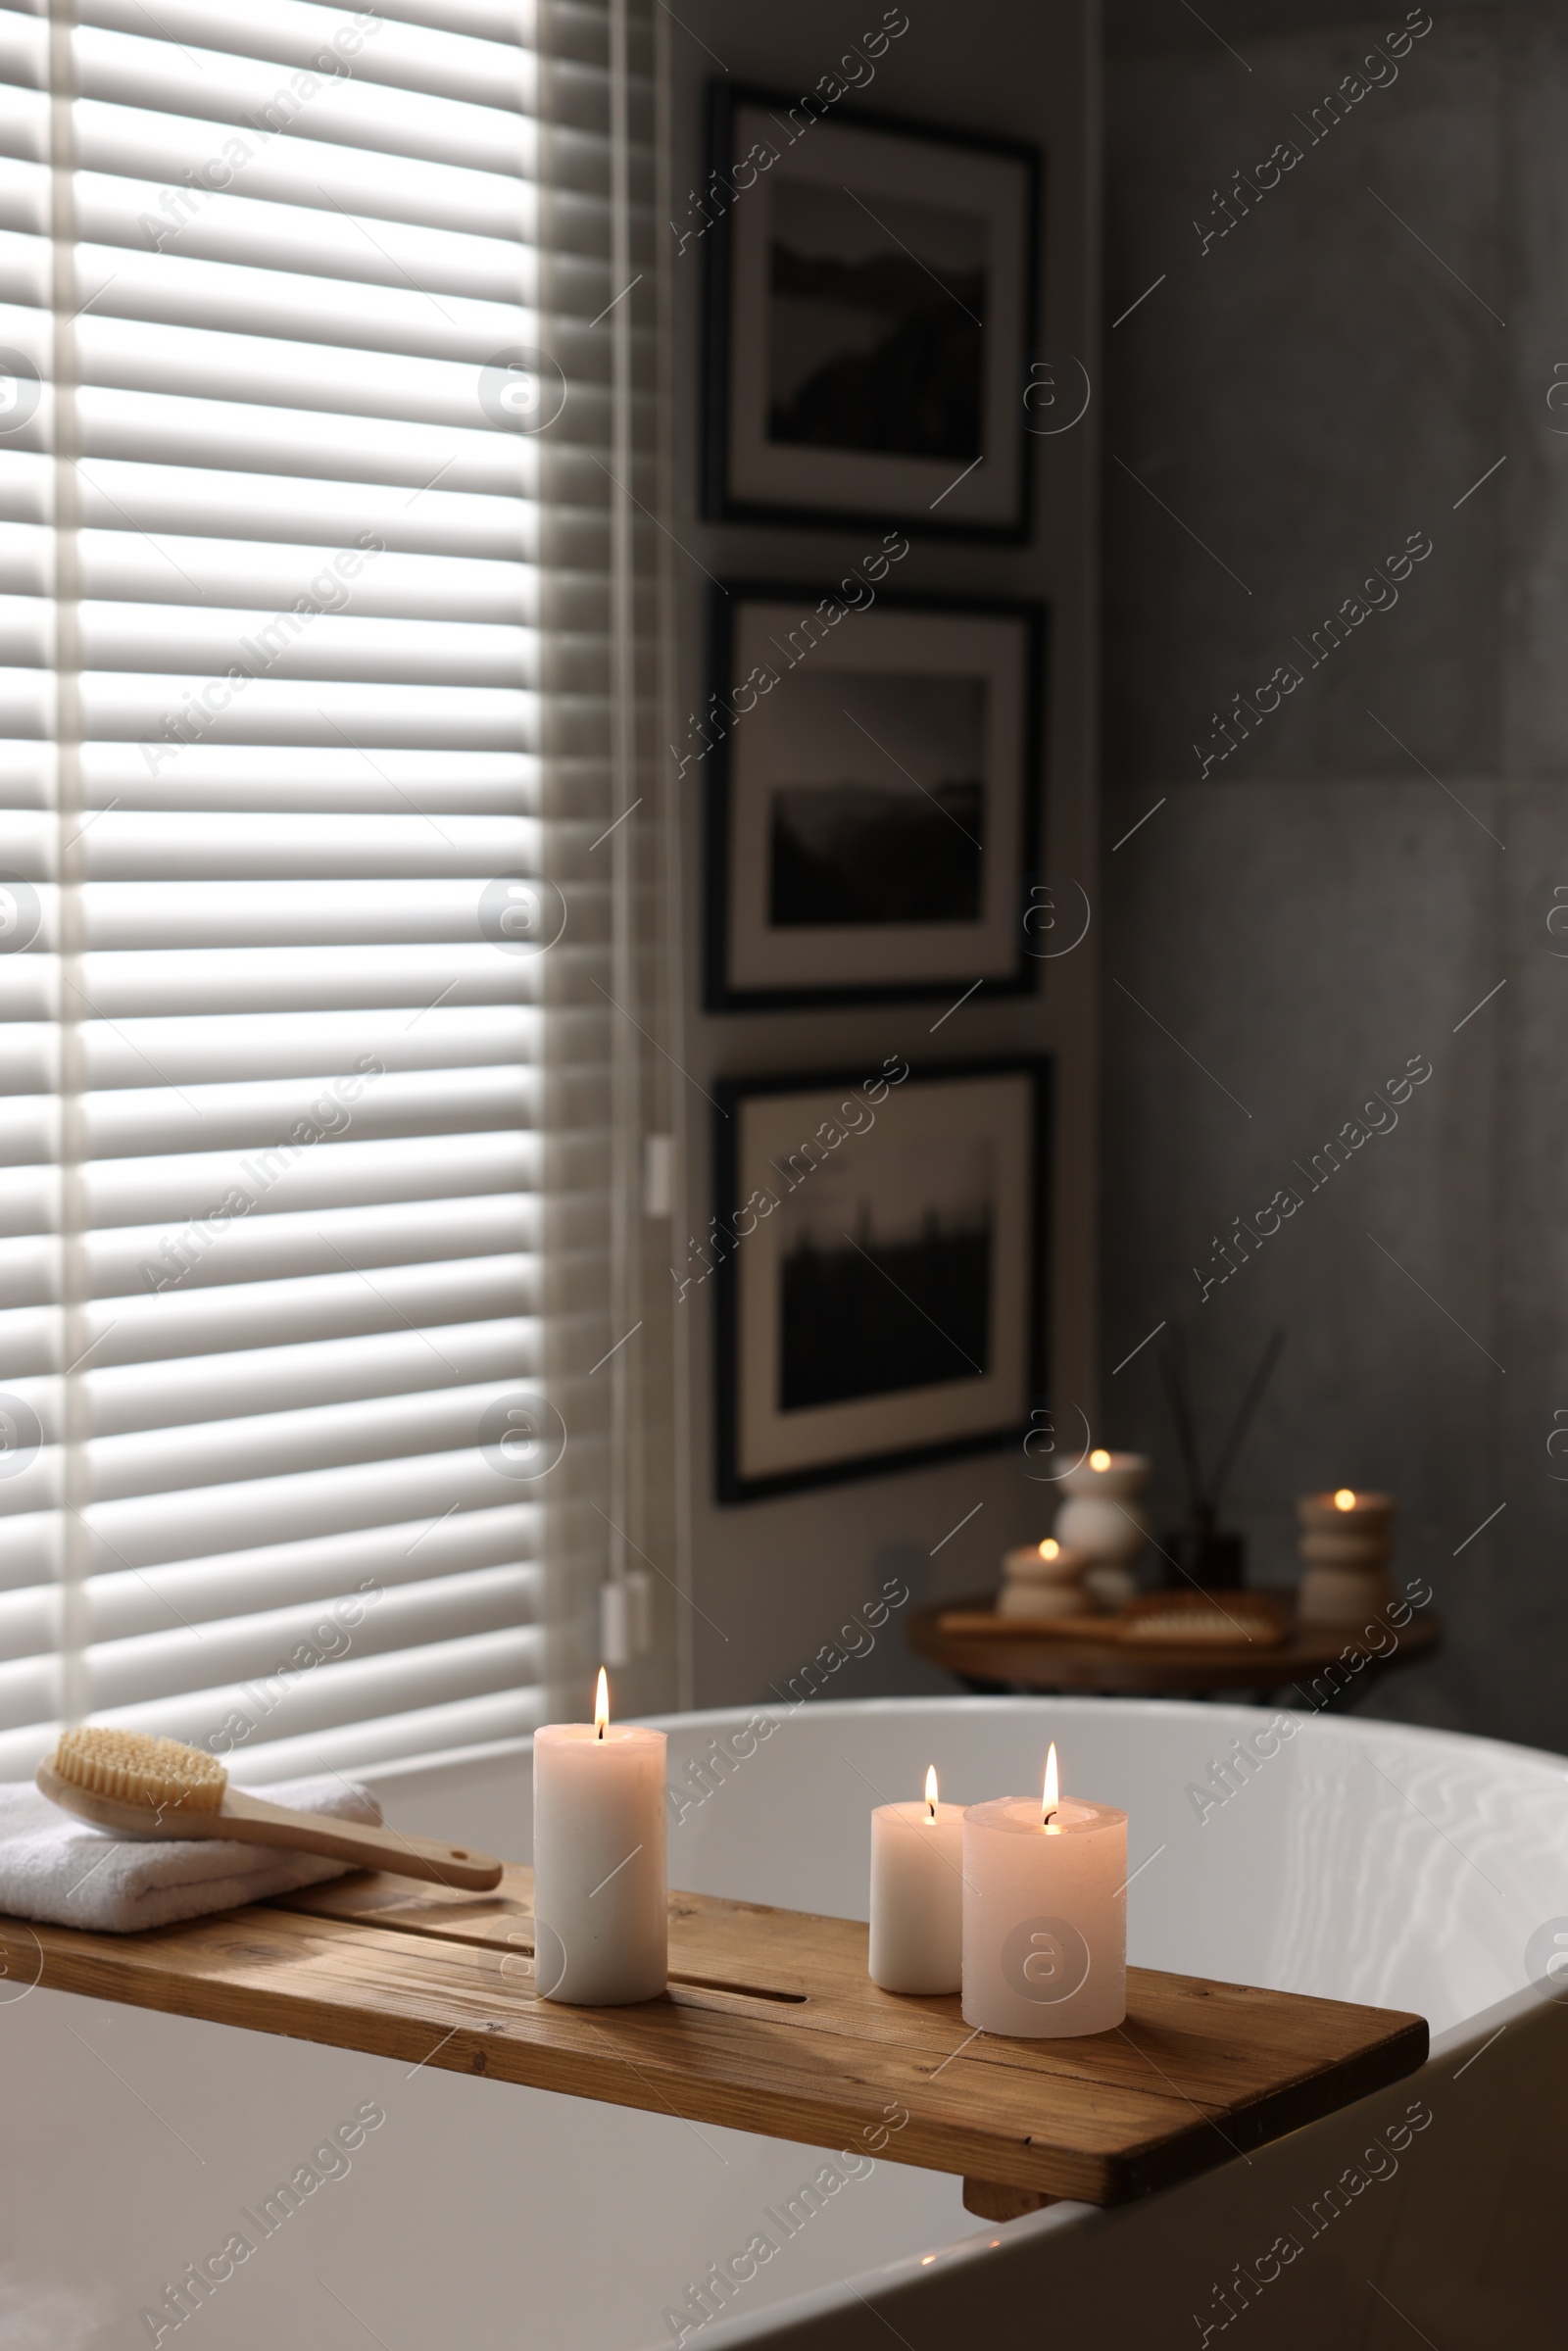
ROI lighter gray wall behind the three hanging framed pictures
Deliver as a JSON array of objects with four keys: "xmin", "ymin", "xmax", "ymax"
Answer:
[{"xmin": 667, "ymin": 0, "xmax": 1098, "ymax": 1704}]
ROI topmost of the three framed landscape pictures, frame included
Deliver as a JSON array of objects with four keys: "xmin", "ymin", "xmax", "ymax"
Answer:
[{"xmin": 701, "ymin": 82, "xmax": 1039, "ymax": 538}]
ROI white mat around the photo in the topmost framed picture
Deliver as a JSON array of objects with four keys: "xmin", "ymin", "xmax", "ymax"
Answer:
[{"xmin": 729, "ymin": 106, "xmax": 1030, "ymax": 526}]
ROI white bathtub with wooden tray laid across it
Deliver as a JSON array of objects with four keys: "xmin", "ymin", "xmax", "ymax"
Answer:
[{"xmin": 0, "ymin": 1697, "xmax": 1568, "ymax": 2351}]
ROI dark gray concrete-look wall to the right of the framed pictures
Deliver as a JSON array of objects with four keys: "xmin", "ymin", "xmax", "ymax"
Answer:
[{"xmin": 1102, "ymin": 0, "xmax": 1568, "ymax": 1749}]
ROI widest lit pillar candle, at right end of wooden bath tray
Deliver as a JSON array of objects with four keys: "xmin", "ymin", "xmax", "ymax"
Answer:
[{"xmin": 964, "ymin": 1746, "xmax": 1126, "ymax": 2040}]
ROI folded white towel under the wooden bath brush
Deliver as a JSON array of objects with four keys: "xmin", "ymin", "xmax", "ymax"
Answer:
[{"xmin": 0, "ymin": 1780, "xmax": 381, "ymax": 1935}]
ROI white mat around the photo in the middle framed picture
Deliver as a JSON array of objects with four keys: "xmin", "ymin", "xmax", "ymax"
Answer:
[{"xmin": 726, "ymin": 602, "xmax": 1034, "ymax": 990}]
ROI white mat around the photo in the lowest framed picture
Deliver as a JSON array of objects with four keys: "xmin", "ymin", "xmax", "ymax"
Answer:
[{"xmin": 733, "ymin": 1072, "xmax": 1042, "ymax": 1479}]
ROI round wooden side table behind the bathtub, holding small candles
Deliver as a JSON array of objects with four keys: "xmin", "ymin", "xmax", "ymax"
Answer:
[{"xmin": 907, "ymin": 1594, "xmax": 1444, "ymax": 1714}]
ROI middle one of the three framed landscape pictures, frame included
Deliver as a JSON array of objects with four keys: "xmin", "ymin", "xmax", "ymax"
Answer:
[{"xmin": 703, "ymin": 581, "xmax": 1044, "ymax": 1011}]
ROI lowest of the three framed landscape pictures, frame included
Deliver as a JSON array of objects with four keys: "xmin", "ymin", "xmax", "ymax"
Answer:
[{"xmin": 714, "ymin": 1055, "xmax": 1051, "ymax": 1502}]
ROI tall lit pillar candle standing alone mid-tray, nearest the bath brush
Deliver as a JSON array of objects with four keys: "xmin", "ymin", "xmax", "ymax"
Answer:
[{"xmin": 534, "ymin": 1672, "xmax": 670, "ymax": 2008}]
